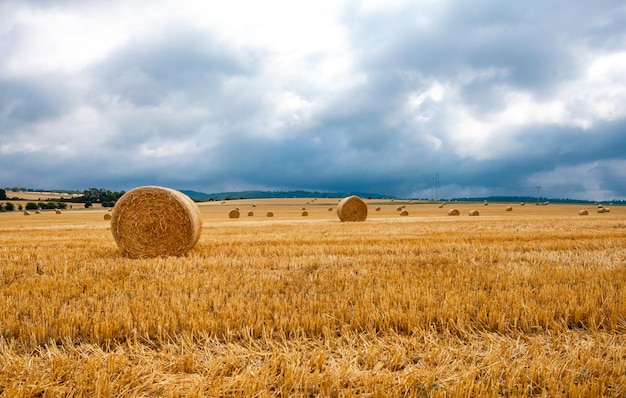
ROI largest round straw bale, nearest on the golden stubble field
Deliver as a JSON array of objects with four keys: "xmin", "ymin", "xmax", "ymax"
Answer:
[{"xmin": 111, "ymin": 186, "xmax": 202, "ymax": 258}]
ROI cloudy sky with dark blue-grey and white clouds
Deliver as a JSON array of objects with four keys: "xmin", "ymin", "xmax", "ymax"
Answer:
[{"xmin": 0, "ymin": 0, "xmax": 626, "ymax": 200}]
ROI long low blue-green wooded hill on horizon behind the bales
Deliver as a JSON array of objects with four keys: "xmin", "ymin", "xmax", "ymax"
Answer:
[{"xmin": 180, "ymin": 190, "xmax": 395, "ymax": 202}]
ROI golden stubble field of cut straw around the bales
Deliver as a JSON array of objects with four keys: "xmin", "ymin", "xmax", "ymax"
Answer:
[{"xmin": 0, "ymin": 199, "xmax": 626, "ymax": 397}]
